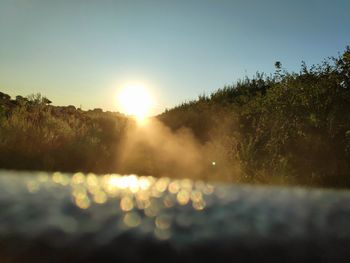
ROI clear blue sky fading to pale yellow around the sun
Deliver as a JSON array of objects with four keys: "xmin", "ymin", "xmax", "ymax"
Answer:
[{"xmin": 0, "ymin": 0, "xmax": 350, "ymax": 114}]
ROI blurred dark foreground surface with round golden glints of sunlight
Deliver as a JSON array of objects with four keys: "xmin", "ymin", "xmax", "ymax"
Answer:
[{"xmin": 0, "ymin": 171, "xmax": 350, "ymax": 262}]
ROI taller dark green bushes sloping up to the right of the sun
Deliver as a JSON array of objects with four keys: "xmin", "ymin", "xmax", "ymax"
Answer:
[{"xmin": 160, "ymin": 47, "xmax": 350, "ymax": 187}]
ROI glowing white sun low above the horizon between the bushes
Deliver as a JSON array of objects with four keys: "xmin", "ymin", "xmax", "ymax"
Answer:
[{"xmin": 117, "ymin": 84, "xmax": 154, "ymax": 121}]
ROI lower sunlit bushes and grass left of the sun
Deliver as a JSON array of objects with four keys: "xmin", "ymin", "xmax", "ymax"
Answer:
[{"xmin": 0, "ymin": 93, "xmax": 129, "ymax": 172}]
